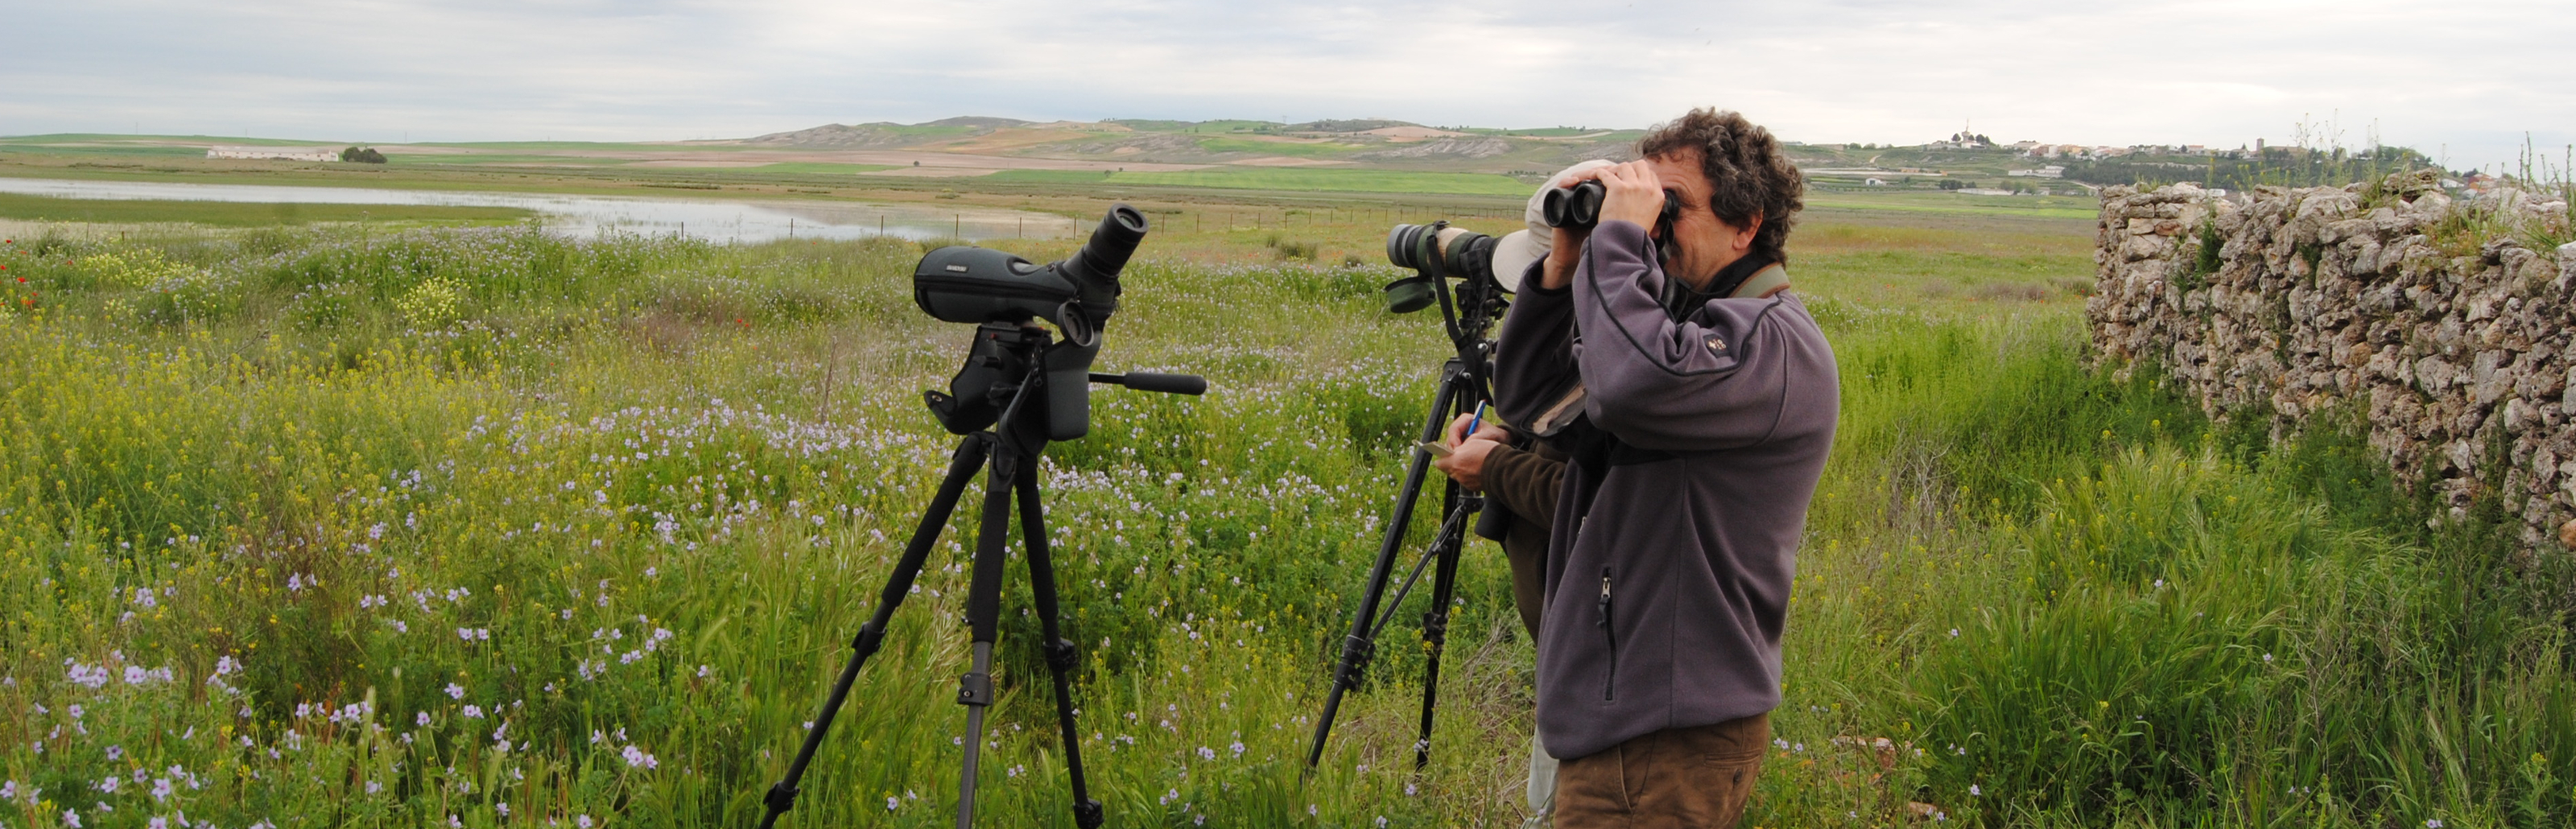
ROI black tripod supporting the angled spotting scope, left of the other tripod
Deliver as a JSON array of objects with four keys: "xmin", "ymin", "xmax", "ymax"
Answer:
[{"xmin": 760, "ymin": 322, "xmax": 1208, "ymax": 829}]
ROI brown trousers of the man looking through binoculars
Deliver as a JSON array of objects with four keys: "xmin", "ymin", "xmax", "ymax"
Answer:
[{"xmin": 1556, "ymin": 713, "xmax": 1769, "ymax": 829}]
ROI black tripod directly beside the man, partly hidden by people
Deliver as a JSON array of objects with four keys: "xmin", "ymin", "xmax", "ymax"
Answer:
[{"xmin": 1306, "ymin": 231, "xmax": 1505, "ymax": 773}]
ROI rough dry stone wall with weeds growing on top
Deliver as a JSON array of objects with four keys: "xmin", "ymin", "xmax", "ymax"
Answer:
[{"xmin": 2084, "ymin": 172, "xmax": 2576, "ymax": 548}]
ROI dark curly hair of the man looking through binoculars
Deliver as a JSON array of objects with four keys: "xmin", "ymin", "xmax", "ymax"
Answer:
[{"xmin": 1636, "ymin": 108, "xmax": 1806, "ymax": 265}]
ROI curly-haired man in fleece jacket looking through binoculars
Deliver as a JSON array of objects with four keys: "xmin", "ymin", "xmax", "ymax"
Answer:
[{"xmin": 1440, "ymin": 111, "xmax": 1839, "ymax": 829}]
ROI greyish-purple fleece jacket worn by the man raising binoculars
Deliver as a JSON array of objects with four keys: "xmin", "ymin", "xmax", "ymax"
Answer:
[{"xmin": 1494, "ymin": 221, "xmax": 1842, "ymax": 760}]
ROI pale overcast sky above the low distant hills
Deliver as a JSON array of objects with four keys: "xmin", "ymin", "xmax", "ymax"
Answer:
[{"xmin": 0, "ymin": 0, "xmax": 2576, "ymax": 167}]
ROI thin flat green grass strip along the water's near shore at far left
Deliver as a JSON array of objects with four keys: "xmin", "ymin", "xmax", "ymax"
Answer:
[{"xmin": 0, "ymin": 193, "xmax": 536, "ymax": 226}]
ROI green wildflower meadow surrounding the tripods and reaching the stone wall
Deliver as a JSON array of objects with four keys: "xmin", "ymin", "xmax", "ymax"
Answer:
[{"xmin": 0, "ymin": 189, "xmax": 2576, "ymax": 829}]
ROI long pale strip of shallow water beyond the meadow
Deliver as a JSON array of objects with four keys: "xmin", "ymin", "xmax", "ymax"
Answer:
[{"xmin": 0, "ymin": 178, "xmax": 1082, "ymax": 242}]
